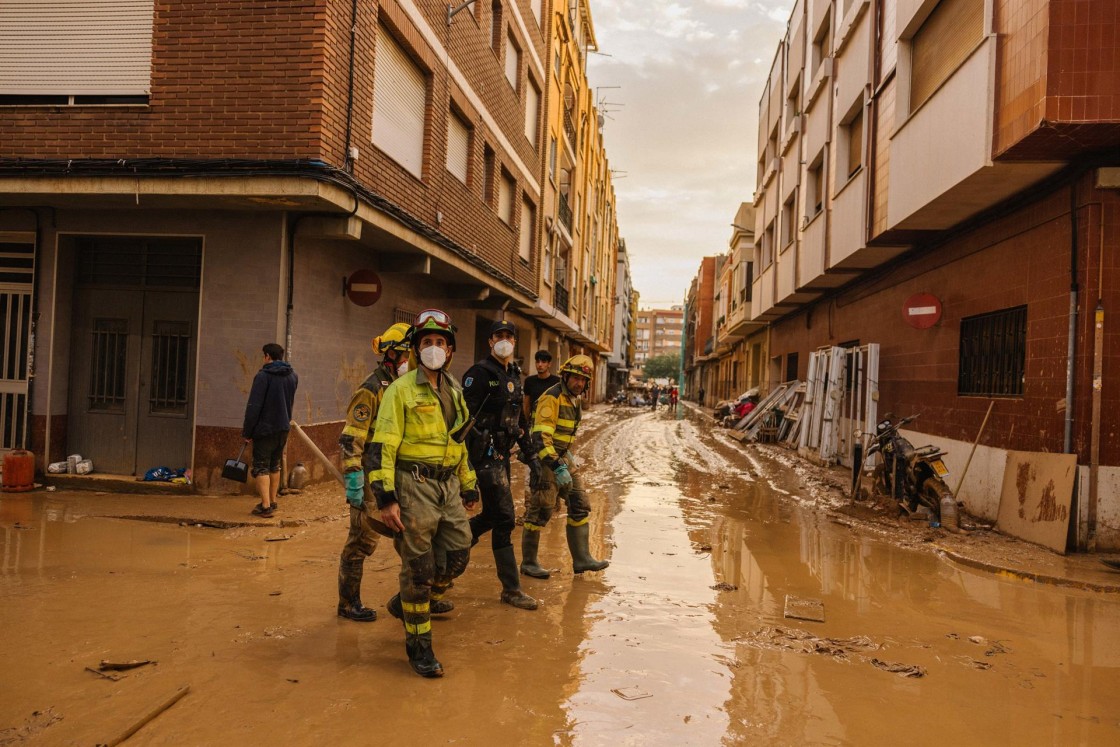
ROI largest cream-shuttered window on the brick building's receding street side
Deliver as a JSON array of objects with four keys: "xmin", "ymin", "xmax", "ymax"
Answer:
[{"xmin": 373, "ymin": 26, "xmax": 428, "ymax": 178}]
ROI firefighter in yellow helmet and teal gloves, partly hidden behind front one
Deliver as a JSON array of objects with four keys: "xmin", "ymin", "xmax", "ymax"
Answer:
[{"xmin": 338, "ymin": 324, "xmax": 418, "ymax": 623}]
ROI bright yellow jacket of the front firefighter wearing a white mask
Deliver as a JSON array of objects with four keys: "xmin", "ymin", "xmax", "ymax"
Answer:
[{"xmin": 365, "ymin": 368, "xmax": 477, "ymax": 507}]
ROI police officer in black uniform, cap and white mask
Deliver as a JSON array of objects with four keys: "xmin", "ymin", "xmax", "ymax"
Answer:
[{"xmin": 463, "ymin": 320, "xmax": 540, "ymax": 609}]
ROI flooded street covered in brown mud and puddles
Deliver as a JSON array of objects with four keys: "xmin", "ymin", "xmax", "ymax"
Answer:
[{"xmin": 0, "ymin": 407, "xmax": 1120, "ymax": 745}]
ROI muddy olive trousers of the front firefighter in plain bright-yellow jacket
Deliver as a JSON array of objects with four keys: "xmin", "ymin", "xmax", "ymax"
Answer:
[{"xmin": 393, "ymin": 469, "xmax": 470, "ymax": 635}]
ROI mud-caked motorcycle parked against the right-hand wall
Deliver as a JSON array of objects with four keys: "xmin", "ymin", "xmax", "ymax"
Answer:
[{"xmin": 864, "ymin": 414, "xmax": 956, "ymax": 527}]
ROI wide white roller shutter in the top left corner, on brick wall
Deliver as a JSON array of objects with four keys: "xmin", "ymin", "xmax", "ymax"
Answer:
[{"xmin": 0, "ymin": 0, "xmax": 155, "ymax": 96}]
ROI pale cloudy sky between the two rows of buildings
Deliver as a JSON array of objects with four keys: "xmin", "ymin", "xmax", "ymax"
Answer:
[{"xmin": 588, "ymin": 0, "xmax": 793, "ymax": 308}]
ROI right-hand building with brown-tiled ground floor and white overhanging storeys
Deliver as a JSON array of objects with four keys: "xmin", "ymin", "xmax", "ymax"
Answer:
[{"xmin": 750, "ymin": 0, "xmax": 1120, "ymax": 549}]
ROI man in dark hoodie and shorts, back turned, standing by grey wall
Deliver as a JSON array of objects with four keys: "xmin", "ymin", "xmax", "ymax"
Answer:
[{"xmin": 241, "ymin": 343, "xmax": 299, "ymax": 519}]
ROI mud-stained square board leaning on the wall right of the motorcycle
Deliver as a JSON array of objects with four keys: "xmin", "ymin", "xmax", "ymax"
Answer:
[{"xmin": 999, "ymin": 451, "xmax": 1077, "ymax": 554}]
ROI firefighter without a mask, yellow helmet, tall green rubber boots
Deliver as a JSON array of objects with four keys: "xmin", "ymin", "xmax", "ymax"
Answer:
[{"xmin": 521, "ymin": 355, "xmax": 610, "ymax": 578}]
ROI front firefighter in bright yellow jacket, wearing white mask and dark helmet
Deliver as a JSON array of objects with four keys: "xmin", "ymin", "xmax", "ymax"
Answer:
[{"xmin": 364, "ymin": 309, "xmax": 478, "ymax": 678}]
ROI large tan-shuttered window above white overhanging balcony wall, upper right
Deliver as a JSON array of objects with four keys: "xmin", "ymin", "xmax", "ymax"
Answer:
[{"xmin": 909, "ymin": 0, "xmax": 983, "ymax": 111}]
